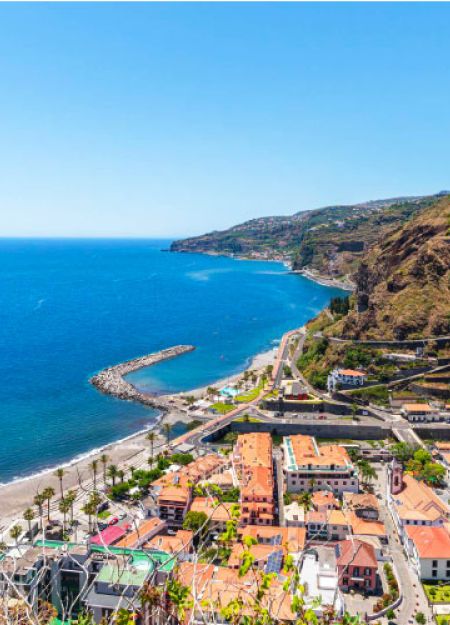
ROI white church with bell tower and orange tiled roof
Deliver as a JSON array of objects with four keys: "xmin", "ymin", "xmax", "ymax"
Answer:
[{"xmin": 387, "ymin": 460, "xmax": 450, "ymax": 544}]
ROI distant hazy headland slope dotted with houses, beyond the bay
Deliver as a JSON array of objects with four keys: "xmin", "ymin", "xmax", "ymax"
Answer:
[{"xmin": 171, "ymin": 196, "xmax": 437, "ymax": 277}]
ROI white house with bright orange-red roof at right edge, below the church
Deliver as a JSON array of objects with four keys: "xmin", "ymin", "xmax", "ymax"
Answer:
[{"xmin": 406, "ymin": 525, "xmax": 450, "ymax": 581}]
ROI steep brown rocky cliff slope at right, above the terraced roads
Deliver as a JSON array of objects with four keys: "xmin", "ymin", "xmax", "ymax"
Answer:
[{"xmin": 342, "ymin": 196, "xmax": 450, "ymax": 339}]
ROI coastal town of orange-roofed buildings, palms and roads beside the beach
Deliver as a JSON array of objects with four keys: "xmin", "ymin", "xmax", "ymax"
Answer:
[{"xmin": 0, "ymin": 302, "xmax": 450, "ymax": 625}]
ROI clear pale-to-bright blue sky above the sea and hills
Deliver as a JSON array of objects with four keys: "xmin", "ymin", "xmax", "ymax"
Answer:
[{"xmin": 0, "ymin": 3, "xmax": 450, "ymax": 236}]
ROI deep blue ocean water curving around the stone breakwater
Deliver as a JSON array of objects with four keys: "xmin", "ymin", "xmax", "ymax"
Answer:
[{"xmin": 0, "ymin": 240, "xmax": 339, "ymax": 482}]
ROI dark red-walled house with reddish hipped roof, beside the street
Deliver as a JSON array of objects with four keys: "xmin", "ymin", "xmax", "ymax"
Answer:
[{"xmin": 336, "ymin": 539, "xmax": 378, "ymax": 593}]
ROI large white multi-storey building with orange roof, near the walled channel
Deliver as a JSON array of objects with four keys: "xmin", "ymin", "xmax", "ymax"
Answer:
[{"xmin": 283, "ymin": 434, "xmax": 359, "ymax": 495}]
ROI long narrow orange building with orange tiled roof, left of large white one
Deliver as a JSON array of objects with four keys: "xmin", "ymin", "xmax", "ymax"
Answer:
[{"xmin": 232, "ymin": 432, "xmax": 275, "ymax": 525}]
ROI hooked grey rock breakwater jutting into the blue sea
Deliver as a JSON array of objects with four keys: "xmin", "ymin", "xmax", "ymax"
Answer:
[{"xmin": 89, "ymin": 345, "xmax": 195, "ymax": 410}]
